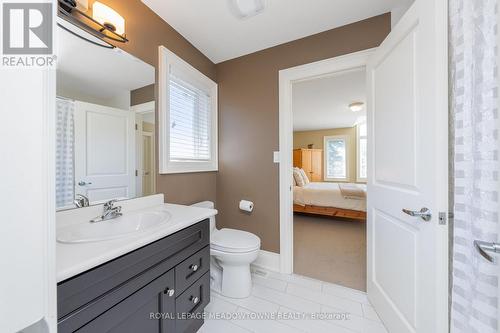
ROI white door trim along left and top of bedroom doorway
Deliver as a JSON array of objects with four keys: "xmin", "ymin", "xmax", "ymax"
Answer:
[{"xmin": 279, "ymin": 48, "xmax": 375, "ymax": 274}]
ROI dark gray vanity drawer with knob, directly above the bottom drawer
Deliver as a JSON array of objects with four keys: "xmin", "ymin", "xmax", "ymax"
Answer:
[{"xmin": 175, "ymin": 245, "xmax": 210, "ymax": 294}]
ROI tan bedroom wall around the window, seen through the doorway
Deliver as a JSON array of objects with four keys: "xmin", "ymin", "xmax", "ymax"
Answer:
[{"xmin": 293, "ymin": 127, "xmax": 357, "ymax": 183}]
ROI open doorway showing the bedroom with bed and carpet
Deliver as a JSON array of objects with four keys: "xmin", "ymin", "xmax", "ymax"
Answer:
[{"xmin": 292, "ymin": 67, "xmax": 367, "ymax": 291}]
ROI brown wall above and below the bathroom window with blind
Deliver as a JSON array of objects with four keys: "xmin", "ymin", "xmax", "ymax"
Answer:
[{"xmin": 85, "ymin": 0, "xmax": 216, "ymax": 204}]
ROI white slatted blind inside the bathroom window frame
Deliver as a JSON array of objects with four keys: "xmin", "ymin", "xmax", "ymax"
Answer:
[{"xmin": 169, "ymin": 74, "xmax": 211, "ymax": 162}]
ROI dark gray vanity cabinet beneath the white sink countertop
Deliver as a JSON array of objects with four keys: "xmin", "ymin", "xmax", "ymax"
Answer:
[{"xmin": 57, "ymin": 220, "xmax": 210, "ymax": 333}]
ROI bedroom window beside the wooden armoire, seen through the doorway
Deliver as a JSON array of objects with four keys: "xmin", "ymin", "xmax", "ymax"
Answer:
[{"xmin": 324, "ymin": 136, "xmax": 348, "ymax": 181}]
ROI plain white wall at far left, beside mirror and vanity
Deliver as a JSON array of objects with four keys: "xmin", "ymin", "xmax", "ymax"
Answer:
[{"xmin": 0, "ymin": 69, "xmax": 56, "ymax": 332}]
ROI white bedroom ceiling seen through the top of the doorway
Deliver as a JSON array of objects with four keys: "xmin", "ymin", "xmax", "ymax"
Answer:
[{"xmin": 292, "ymin": 69, "xmax": 366, "ymax": 131}]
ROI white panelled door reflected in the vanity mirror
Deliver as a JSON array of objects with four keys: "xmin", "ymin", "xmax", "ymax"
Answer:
[{"xmin": 75, "ymin": 102, "xmax": 135, "ymax": 202}]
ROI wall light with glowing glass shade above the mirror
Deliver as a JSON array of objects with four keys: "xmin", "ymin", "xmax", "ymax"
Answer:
[{"xmin": 57, "ymin": 0, "xmax": 128, "ymax": 49}]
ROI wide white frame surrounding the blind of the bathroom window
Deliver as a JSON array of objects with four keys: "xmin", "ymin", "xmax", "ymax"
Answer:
[{"xmin": 158, "ymin": 46, "xmax": 219, "ymax": 174}]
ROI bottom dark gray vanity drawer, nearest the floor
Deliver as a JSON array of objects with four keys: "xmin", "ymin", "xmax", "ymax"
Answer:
[{"xmin": 175, "ymin": 272, "xmax": 210, "ymax": 333}]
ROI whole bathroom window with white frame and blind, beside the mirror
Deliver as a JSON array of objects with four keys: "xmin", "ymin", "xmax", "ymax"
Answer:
[{"xmin": 159, "ymin": 47, "xmax": 218, "ymax": 174}]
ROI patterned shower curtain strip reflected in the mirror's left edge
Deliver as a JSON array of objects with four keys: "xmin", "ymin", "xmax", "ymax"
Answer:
[{"xmin": 56, "ymin": 97, "xmax": 75, "ymax": 208}]
